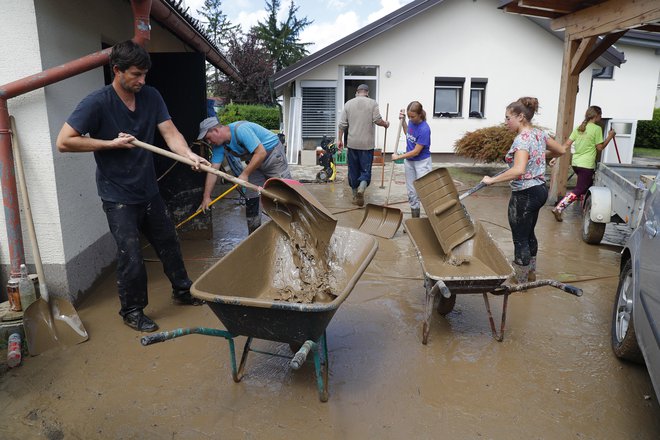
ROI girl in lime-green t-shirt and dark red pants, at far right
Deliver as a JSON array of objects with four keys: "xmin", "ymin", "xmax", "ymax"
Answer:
[{"xmin": 551, "ymin": 105, "xmax": 616, "ymax": 222}]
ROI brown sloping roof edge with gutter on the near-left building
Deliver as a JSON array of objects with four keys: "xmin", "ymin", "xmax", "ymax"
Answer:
[{"xmin": 151, "ymin": 0, "xmax": 241, "ymax": 80}]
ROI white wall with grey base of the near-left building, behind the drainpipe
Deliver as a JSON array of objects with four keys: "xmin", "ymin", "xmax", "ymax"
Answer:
[{"xmin": 0, "ymin": 0, "xmax": 199, "ymax": 296}]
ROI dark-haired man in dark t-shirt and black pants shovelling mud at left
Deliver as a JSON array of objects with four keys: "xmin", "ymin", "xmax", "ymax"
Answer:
[{"xmin": 57, "ymin": 40, "xmax": 210, "ymax": 332}]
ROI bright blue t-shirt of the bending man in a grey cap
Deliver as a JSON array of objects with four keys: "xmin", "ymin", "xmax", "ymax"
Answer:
[{"xmin": 211, "ymin": 121, "xmax": 280, "ymax": 163}]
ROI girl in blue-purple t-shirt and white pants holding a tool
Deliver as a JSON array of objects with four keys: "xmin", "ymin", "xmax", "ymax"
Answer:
[{"xmin": 392, "ymin": 101, "xmax": 433, "ymax": 218}]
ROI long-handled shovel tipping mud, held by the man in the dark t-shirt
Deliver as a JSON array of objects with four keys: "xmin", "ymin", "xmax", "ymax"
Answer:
[{"xmin": 132, "ymin": 139, "xmax": 337, "ymax": 247}]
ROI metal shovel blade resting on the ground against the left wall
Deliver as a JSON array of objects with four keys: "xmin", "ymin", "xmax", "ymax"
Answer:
[{"xmin": 23, "ymin": 296, "xmax": 89, "ymax": 356}]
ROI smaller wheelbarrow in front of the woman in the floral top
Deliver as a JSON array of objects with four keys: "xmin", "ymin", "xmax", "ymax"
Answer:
[{"xmin": 404, "ymin": 218, "xmax": 582, "ymax": 344}]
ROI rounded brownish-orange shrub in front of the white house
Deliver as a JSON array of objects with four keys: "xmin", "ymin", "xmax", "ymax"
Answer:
[{"xmin": 454, "ymin": 124, "xmax": 516, "ymax": 163}]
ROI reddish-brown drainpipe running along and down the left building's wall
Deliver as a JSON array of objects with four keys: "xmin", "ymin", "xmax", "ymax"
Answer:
[{"xmin": 0, "ymin": 0, "xmax": 152, "ymax": 276}]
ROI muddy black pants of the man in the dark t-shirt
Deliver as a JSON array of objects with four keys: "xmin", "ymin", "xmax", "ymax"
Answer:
[{"xmin": 103, "ymin": 194, "xmax": 192, "ymax": 316}]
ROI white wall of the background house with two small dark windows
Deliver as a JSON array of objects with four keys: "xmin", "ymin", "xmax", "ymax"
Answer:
[{"xmin": 285, "ymin": 0, "xmax": 657, "ymax": 153}]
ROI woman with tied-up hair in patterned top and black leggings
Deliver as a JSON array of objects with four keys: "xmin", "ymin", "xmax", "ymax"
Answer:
[{"xmin": 481, "ymin": 97, "xmax": 566, "ymax": 283}]
